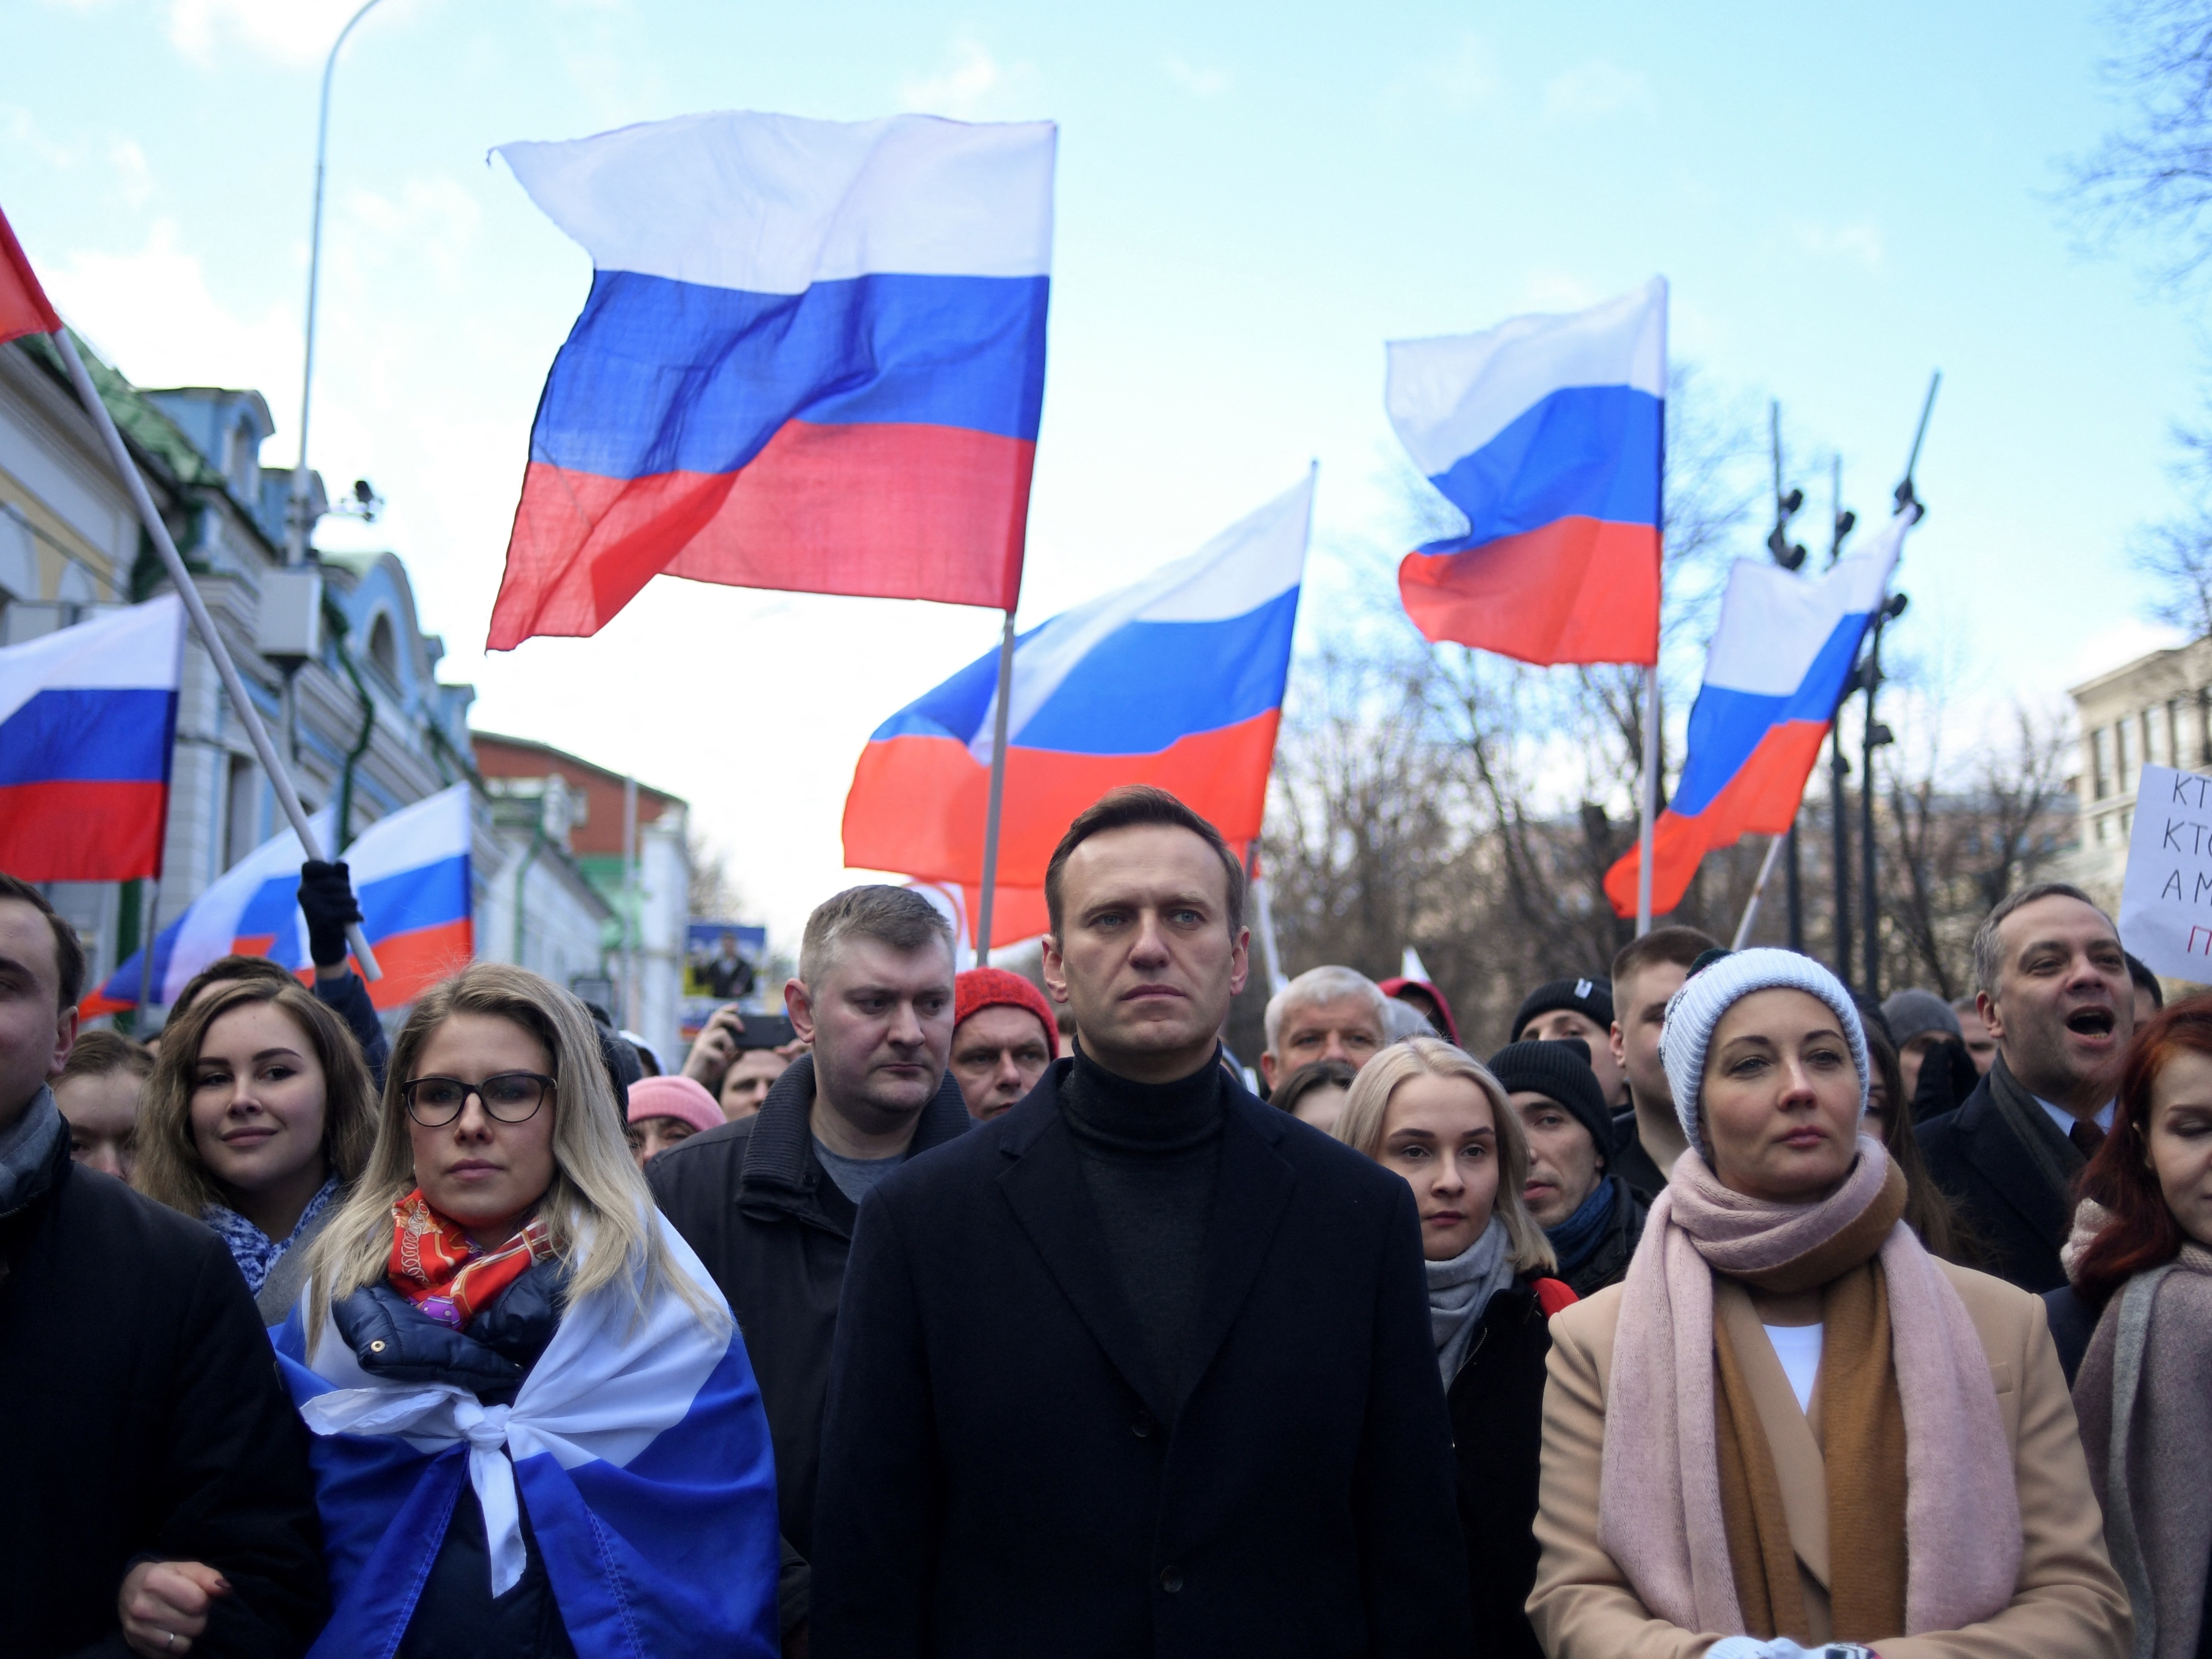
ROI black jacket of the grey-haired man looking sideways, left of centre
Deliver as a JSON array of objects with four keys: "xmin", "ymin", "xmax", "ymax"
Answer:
[{"xmin": 646, "ymin": 1055, "xmax": 971, "ymax": 1630}]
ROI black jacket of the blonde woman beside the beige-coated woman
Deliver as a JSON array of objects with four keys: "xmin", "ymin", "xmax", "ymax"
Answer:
[{"xmin": 1445, "ymin": 1281, "xmax": 1550, "ymax": 1659}]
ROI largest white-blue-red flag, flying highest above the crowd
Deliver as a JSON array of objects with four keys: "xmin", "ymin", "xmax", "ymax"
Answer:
[{"xmin": 491, "ymin": 113, "xmax": 1055, "ymax": 650}]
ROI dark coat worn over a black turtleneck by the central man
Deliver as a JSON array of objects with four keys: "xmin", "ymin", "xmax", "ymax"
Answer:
[{"xmin": 814, "ymin": 1060, "xmax": 1473, "ymax": 1659}]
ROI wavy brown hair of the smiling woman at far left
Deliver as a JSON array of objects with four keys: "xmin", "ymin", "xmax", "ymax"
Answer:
[{"xmin": 130, "ymin": 978, "xmax": 376, "ymax": 1221}]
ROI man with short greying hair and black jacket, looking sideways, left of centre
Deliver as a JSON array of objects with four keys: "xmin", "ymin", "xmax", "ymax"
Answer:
[{"xmin": 646, "ymin": 887, "xmax": 969, "ymax": 1646}]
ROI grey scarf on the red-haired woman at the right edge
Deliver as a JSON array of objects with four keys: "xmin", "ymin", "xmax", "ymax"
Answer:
[{"xmin": 2075, "ymin": 1243, "xmax": 2212, "ymax": 1659}]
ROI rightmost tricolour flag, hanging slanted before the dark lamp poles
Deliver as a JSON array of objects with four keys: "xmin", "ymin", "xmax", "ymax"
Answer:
[{"xmin": 1606, "ymin": 507, "xmax": 1920, "ymax": 916}]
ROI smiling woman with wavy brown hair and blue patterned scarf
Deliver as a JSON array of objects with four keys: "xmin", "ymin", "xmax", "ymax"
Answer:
[{"xmin": 130, "ymin": 980, "xmax": 376, "ymax": 1325}]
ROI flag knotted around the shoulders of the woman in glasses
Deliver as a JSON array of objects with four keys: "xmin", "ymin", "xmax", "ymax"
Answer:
[{"xmin": 277, "ymin": 1214, "xmax": 781, "ymax": 1659}]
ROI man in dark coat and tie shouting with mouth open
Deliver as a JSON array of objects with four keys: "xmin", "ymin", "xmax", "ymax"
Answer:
[{"xmin": 1920, "ymin": 883, "xmax": 2134, "ymax": 1294}]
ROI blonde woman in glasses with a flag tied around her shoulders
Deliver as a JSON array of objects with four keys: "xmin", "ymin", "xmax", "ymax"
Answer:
[{"xmin": 277, "ymin": 962, "xmax": 779, "ymax": 1659}]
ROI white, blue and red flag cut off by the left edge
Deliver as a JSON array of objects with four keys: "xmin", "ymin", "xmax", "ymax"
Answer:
[{"xmin": 0, "ymin": 593, "xmax": 184, "ymax": 880}]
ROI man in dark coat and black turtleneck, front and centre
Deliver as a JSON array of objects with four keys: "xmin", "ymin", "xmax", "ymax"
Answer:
[{"xmin": 814, "ymin": 788, "xmax": 1476, "ymax": 1659}]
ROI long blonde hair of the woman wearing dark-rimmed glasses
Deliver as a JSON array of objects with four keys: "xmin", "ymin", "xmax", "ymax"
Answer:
[{"xmin": 307, "ymin": 962, "xmax": 723, "ymax": 1360}]
